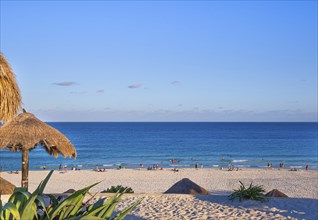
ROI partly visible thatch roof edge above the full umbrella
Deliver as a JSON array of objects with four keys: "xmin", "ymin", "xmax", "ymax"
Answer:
[{"xmin": 0, "ymin": 53, "xmax": 21, "ymax": 122}]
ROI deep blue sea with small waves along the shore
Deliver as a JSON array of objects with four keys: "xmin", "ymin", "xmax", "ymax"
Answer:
[{"xmin": 0, "ymin": 122, "xmax": 318, "ymax": 170}]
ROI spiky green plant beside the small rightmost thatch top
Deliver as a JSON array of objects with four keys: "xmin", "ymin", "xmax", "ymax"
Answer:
[{"xmin": 229, "ymin": 181, "xmax": 267, "ymax": 202}]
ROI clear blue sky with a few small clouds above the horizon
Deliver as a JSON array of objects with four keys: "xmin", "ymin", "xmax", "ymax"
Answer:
[{"xmin": 1, "ymin": 1, "xmax": 317, "ymax": 121}]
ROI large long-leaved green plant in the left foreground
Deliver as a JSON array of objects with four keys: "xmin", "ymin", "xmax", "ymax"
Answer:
[{"xmin": 0, "ymin": 171, "xmax": 141, "ymax": 220}]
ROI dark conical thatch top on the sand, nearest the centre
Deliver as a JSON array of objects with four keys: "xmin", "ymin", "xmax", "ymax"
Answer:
[{"xmin": 165, "ymin": 178, "xmax": 210, "ymax": 195}]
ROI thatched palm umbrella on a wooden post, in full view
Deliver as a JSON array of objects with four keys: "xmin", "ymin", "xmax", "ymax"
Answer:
[{"xmin": 0, "ymin": 112, "xmax": 76, "ymax": 188}]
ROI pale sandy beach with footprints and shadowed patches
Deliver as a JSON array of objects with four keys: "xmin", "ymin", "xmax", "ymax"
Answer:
[{"xmin": 1, "ymin": 169, "xmax": 318, "ymax": 219}]
